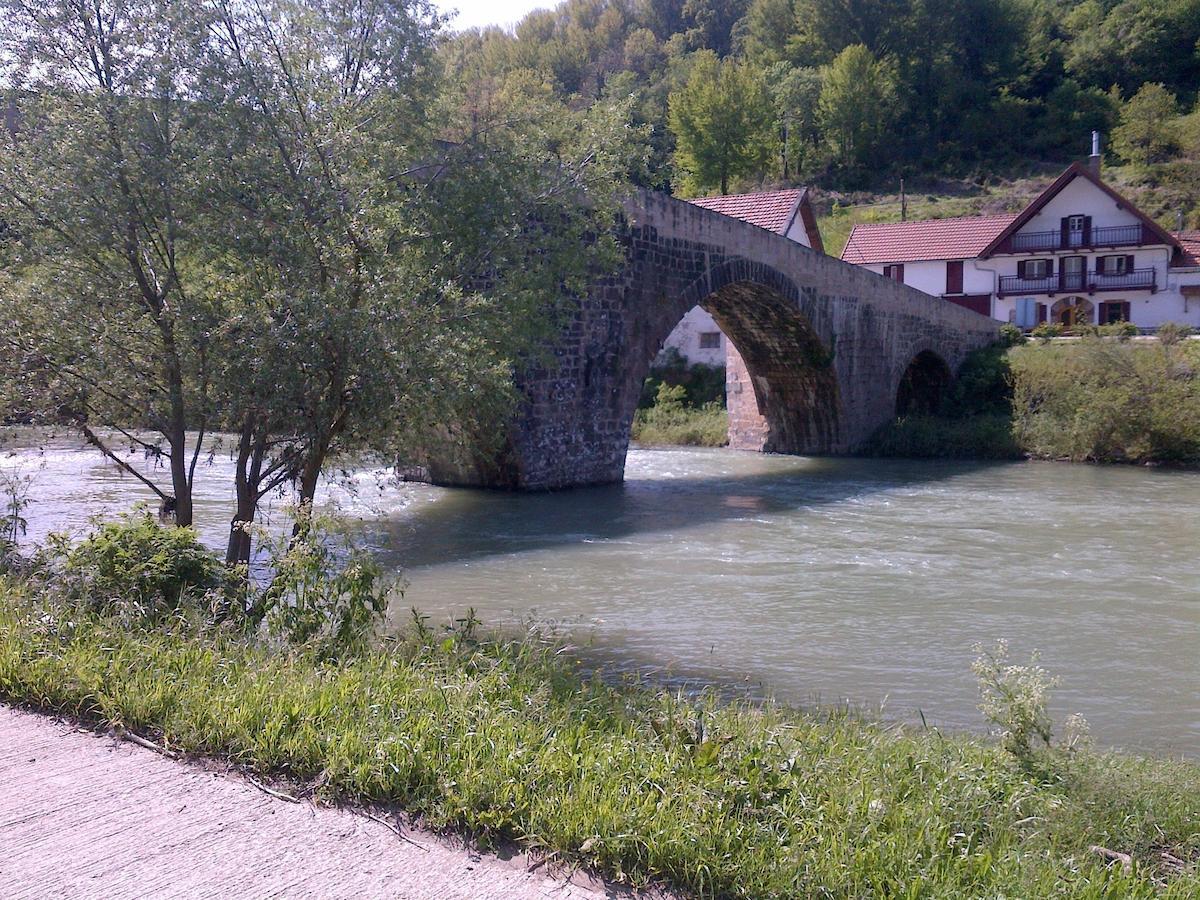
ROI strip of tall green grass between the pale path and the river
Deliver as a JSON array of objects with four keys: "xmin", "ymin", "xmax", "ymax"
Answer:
[{"xmin": 0, "ymin": 573, "xmax": 1200, "ymax": 898}]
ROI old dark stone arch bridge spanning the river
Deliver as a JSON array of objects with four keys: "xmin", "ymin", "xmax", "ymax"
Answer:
[{"xmin": 428, "ymin": 191, "xmax": 997, "ymax": 490}]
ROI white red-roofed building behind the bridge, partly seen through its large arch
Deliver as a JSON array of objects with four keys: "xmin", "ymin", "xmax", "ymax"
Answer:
[{"xmin": 659, "ymin": 187, "xmax": 824, "ymax": 366}]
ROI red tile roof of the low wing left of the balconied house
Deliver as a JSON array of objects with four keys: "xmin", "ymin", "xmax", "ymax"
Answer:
[{"xmin": 841, "ymin": 214, "xmax": 1016, "ymax": 265}]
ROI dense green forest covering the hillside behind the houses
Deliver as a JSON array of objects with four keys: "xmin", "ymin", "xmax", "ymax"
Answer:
[{"xmin": 444, "ymin": 0, "xmax": 1200, "ymax": 217}]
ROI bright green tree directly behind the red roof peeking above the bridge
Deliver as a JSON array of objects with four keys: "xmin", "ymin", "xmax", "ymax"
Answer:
[{"xmin": 668, "ymin": 50, "xmax": 775, "ymax": 193}]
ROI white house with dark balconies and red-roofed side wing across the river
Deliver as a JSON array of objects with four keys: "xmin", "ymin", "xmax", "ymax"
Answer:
[{"xmin": 841, "ymin": 156, "xmax": 1200, "ymax": 329}]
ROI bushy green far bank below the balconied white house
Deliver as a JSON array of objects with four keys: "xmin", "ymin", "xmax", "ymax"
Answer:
[{"xmin": 865, "ymin": 331, "xmax": 1200, "ymax": 466}]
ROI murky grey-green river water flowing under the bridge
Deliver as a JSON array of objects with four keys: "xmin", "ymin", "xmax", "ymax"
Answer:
[{"xmin": 0, "ymin": 432, "xmax": 1200, "ymax": 756}]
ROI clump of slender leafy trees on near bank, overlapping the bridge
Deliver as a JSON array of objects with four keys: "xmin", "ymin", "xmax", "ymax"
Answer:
[{"xmin": 0, "ymin": 0, "xmax": 638, "ymax": 562}]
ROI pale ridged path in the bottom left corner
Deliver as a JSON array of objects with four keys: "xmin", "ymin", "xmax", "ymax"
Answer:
[{"xmin": 0, "ymin": 704, "xmax": 613, "ymax": 900}]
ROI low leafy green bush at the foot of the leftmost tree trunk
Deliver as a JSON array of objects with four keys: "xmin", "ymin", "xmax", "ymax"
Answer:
[{"xmin": 51, "ymin": 512, "xmax": 230, "ymax": 619}]
